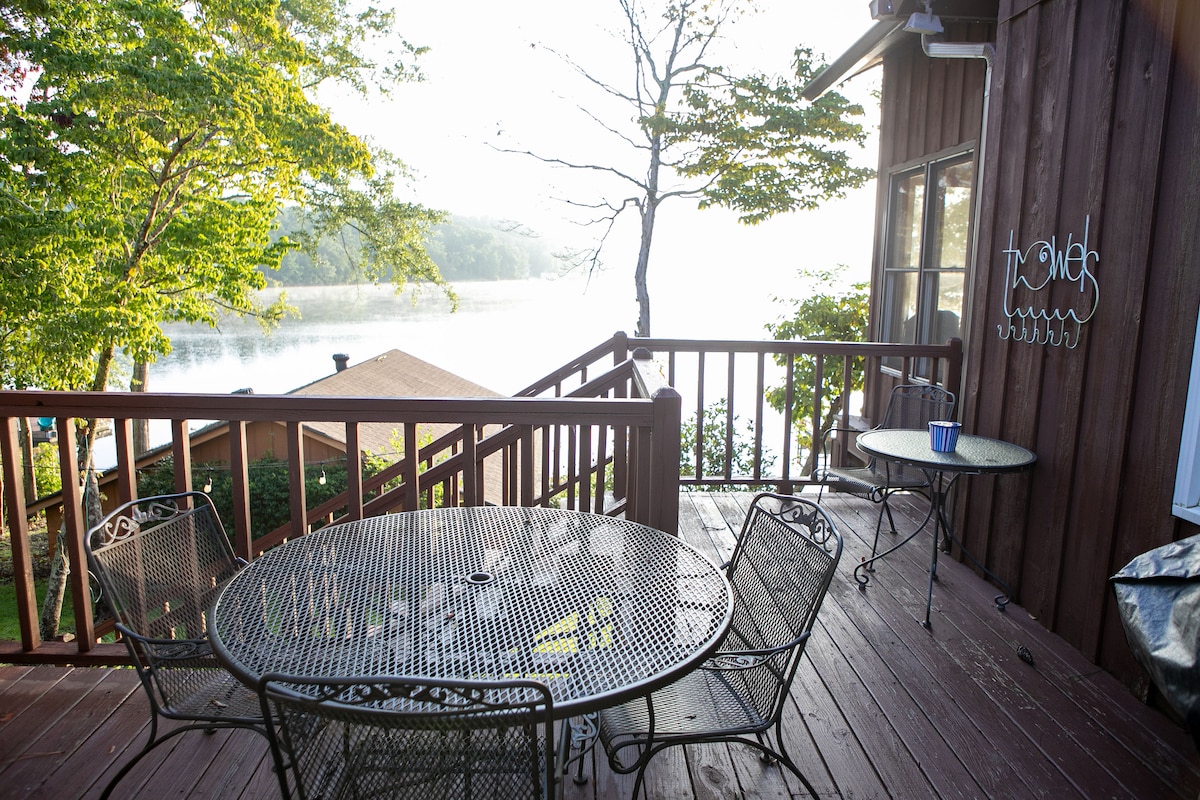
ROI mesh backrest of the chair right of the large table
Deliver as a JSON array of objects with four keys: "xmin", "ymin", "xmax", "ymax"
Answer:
[{"xmin": 716, "ymin": 493, "xmax": 841, "ymax": 720}]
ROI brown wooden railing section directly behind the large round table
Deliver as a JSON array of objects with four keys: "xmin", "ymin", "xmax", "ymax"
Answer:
[{"xmin": 0, "ymin": 359, "xmax": 679, "ymax": 663}]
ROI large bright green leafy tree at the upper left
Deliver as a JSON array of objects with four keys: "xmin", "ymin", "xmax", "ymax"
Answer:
[{"xmin": 0, "ymin": 0, "xmax": 442, "ymax": 637}]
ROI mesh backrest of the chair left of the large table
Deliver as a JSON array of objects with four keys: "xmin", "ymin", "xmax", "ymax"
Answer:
[{"xmin": 85, "ymin": 492, "xmax": 241, "ymax": 639}]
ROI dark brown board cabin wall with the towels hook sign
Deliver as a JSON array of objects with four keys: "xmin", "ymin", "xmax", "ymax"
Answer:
[{"xmin": 958, "ymin": 0, "xmax": 1200, "ymax": 693}]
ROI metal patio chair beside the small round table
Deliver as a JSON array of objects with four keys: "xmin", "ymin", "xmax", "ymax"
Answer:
[{"xmin": 815, "ymin": 385, "xmax": 954, "ymax": 555}]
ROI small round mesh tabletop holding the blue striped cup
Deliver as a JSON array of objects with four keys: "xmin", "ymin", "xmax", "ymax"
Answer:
[{"xmin": 858, "ymin": 428, "xmax": 1038, "ymax": 473}]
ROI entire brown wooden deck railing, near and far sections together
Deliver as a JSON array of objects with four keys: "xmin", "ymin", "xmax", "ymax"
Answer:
[{"xmin": 0, "ymin": 333, "xmax": 962, "ymax": 663}]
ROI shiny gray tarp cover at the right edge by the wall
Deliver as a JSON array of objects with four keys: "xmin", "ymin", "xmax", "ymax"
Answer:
[{"xmin": 1112, "ymin": 536, "xmax": 1200, "ymax": 745}]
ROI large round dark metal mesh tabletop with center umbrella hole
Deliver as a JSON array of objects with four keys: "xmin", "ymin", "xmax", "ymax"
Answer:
[{"xmin": 209, "ymin": 506, "xmax": 732, "ymax": 716}]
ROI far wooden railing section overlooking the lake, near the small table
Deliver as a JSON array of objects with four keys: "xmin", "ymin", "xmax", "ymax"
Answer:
[{"xmin": 521, "ymin": 332, "xmax": 962, "ymax": 492}]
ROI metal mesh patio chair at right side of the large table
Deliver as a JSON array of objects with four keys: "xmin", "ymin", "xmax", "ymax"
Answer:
[{"xmin": 599, "ymin": 493, "xmax": 841, "ymax": 798}]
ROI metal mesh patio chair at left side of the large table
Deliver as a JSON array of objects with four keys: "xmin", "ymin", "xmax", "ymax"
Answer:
[{"xmin": 85, "ymin": 492, "xmax": 266, "ymax": 798}]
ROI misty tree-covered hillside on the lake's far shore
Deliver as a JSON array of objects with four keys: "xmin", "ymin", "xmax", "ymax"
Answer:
[{"xmin": 266, "ymin": 207, "xmax": 560, "ymax": 285}]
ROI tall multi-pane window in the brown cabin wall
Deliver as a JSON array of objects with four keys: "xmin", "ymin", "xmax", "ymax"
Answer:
[{"xmin": 881, "ymin": 152, "xmax": 974, "ymax": 379}]
